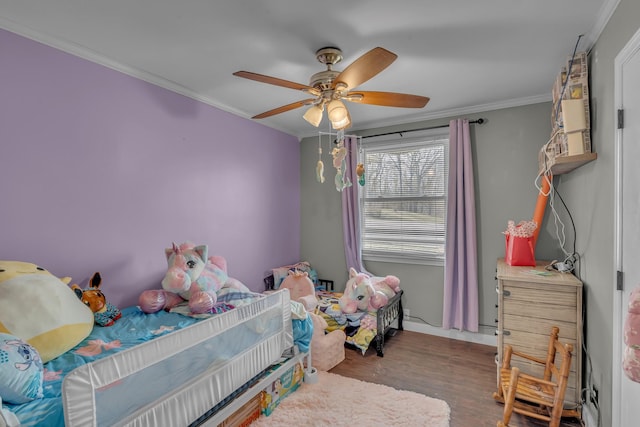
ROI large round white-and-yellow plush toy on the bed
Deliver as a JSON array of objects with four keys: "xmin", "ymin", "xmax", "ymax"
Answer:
[{"xmin": 0, "ymin": 260, "xmax": 94, "ymax": 363}]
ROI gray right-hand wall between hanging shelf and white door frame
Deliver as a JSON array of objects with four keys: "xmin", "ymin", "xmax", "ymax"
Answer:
[{"xmin": 560, "ymin": 0, "xmax": 640, "ymax": 426}]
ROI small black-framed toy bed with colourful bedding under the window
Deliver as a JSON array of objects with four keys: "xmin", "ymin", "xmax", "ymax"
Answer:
[{"xmin": 316, "ymin": 290, "xmax": 404, "ymax": 357}]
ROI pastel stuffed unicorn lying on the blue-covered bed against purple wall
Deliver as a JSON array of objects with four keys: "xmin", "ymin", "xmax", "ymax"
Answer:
[{"xmin": 138, "ymin": 242, "xmax": 251, "ymax": 314}]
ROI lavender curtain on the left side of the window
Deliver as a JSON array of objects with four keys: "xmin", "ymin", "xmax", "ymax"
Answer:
[{"xmin": 342, "ymin": 136, "xmax": 367, "ymax": 273}]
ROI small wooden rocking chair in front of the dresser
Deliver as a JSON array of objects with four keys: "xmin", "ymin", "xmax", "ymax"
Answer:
[{"xmin": 493, "ymin": 326, "xmax": 576, "ymax": 427}]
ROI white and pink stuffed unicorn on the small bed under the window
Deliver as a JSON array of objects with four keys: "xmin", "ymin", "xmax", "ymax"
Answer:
[{"xmin": 339, "ymin": 268, "xmax": 400, "ymax": 314}]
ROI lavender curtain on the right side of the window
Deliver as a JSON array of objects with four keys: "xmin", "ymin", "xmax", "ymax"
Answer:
[{"xmin": 442, "ymin": 119, "xmax": 478, "ymax": 332}]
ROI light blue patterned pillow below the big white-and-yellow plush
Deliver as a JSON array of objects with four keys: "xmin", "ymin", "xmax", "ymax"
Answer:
[{"xmin": 0, "ymin": 333, "xmax": 44, "ymax": 404}]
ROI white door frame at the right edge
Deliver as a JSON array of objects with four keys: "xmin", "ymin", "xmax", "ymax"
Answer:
[{"xmin": 611, "ymin": 25, "xmax": 640, "ymax": 426}]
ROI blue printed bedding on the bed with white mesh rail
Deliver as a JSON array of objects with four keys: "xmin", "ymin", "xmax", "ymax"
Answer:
[{"xmin": 3, "ymin": 290, "xmax": 310, "ymax": 427}]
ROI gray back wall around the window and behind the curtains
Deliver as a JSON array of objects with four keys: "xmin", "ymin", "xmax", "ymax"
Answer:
[{"xmin": 300, "ymin": 103, "xmax": 561, "ymax": 334}]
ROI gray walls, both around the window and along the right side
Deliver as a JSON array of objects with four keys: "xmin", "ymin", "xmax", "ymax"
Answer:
[{"xmin": 301, "ymin": 0, "xmax": 640, "ymax": 426}]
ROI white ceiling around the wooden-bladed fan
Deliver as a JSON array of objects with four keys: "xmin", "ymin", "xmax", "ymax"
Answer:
[{"xmin": 0, "ymin": 0, "xmax": 619, "ymax": 137}]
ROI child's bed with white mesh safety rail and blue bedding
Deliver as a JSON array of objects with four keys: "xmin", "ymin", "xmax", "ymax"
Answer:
[{"xmin": 0, "ymin": 291, "xmax": 305, "ymax": 427}]
